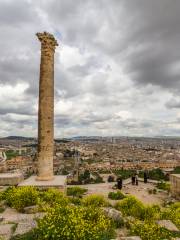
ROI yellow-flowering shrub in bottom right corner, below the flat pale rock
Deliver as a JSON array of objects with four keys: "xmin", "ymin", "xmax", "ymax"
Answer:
[{"xmin": 130, "ymin": 221, "xmax": 173, "ymax": 240}]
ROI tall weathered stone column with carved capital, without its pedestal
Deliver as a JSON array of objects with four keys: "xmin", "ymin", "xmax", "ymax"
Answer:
[{"xmin": 36, "ymin": 32, "xmax": 58, "ymax": 180}]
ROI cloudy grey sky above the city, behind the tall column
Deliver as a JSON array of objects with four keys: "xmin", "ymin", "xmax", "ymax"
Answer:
[{"xmin": 0, "ymin": 0, "xmax": 180, "ymax": 137}]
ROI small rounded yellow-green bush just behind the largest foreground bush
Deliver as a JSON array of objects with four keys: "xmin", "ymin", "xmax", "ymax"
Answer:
[{"xmin": 82, "ymin": 194, "xmax": 109, "ymax": 207}]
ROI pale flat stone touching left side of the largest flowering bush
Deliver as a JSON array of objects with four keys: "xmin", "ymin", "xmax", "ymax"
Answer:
[{"xmin": 13, "ymin": 220, "xmax": 37, "ymax": 236}]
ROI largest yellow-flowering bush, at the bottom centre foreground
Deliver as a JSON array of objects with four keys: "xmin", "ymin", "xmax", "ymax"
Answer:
[{"xmin": 37, "ymin": 205, "xmax": 114, "ymax": 240}]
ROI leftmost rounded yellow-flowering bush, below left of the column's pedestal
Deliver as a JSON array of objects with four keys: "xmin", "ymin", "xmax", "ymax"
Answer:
[{"xmin": 4, "ymin": 186, "xmax": 39, "ymax": 211}]
